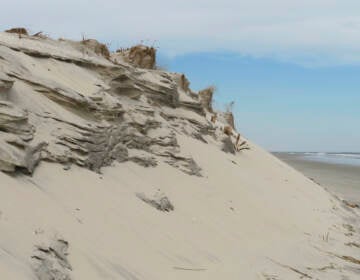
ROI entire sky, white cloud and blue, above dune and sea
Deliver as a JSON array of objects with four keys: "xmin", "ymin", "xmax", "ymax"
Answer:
[{"xmin": 0, "ymin": 0, "xmax": 360, "ymax": 152}]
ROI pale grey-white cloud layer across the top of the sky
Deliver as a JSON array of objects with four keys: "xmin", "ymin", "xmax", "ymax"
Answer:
[{"xmin": 1, "ymin": 0, "xmax": 360, "ymax": 65}]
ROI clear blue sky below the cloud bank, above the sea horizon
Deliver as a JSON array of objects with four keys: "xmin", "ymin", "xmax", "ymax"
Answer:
[{"xmin": 159, "ymin": 52, "xmax": 360, "ymax": 151}]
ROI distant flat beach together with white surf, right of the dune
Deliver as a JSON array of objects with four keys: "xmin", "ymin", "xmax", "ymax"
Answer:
[{"xmin": 274, "ymin": 152, "xmax": 360, "ymax": 203}]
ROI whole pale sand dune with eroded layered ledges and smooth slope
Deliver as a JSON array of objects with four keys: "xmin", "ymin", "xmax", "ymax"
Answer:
[{"xmin": 0, "ymin": 33, "xmax": 360, "ymax": 280}]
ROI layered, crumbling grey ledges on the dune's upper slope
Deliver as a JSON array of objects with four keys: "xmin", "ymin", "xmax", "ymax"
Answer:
[{"xmin": 0, "ymin": 31, "xmax": 219, "ymax": 176}]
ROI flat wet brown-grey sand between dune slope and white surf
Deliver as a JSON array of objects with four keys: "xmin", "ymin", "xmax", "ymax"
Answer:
[{"xmin": 274, "ymin": 153, "xmax": 360, "ymax": 204}]
